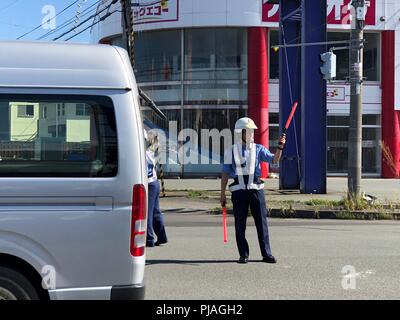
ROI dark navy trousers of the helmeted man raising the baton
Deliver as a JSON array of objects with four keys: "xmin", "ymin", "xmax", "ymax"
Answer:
[{"xmin": 232, "ymin": 190, "xmax": 271, "ymax": 257}]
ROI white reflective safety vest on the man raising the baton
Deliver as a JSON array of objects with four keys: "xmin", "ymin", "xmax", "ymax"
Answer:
[{"xmin": 229, "ymin": 143, "xmax": 264, "ymax": 192}]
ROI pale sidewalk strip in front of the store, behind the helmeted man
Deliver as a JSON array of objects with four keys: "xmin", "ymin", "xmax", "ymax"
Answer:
[{"xmin": 160, "ymin": 178, "xmax": 400, "ymax": 218}]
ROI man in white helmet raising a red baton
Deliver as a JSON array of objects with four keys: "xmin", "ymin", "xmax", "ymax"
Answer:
[{"xmin": 220, "ymin": 118, "xmax": 286, "ymax": 263}]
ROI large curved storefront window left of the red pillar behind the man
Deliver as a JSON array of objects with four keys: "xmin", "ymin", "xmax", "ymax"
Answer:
[{"xmin": 135, "ymin": 28, "xmax": 247, "ymax": 176}]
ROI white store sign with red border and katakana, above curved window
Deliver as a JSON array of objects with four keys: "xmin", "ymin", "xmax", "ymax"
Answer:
[{"xmin": 132, "ymin": 0, "xmax": 179, "ymax": 24}]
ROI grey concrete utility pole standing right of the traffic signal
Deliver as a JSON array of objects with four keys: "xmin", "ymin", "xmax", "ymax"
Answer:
[{"xmin": 348, "ymin": 0, "xmax": 366, "ymax": 199}]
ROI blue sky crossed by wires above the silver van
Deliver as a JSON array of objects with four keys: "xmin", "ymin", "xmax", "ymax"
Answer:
[{"xmin": 0, "ymin": 0, "xmax": 98, "ymax": 42}]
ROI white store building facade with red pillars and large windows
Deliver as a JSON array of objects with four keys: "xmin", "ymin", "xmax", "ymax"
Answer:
[{"xmin": 92, "ymin": 0, "xmax": 400, "ymax": 178}]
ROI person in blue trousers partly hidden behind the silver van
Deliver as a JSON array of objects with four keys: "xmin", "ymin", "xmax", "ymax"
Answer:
[{"xmin": 144, "ymin": 130, "xmax": 168, "ymax": 247}]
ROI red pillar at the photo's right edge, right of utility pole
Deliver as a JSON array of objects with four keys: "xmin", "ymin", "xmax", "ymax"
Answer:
[{"xmin": 382, "ymin": 31, "xmax": 400, "ymax": 178}]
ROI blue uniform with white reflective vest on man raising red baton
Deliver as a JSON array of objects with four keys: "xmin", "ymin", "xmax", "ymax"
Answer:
[{"xmin": 222, "ymin": 143, "xmax": 274, "ymax": 257}]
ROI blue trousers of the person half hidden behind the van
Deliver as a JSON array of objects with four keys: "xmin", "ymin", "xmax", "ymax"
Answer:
[{"xmin": 146, "ymin": 181, "xmax": 167, "ymax": 246}]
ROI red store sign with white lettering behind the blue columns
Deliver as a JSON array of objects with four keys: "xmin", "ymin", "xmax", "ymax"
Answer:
[{"xmin": 262, "ymin": 0, "xmax": 376, "ymax": 26}]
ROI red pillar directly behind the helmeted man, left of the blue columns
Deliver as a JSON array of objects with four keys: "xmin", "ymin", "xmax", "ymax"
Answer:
[{"xmin": 248, "ymin": 27, "xmax": 269, "ymax": 178}]
